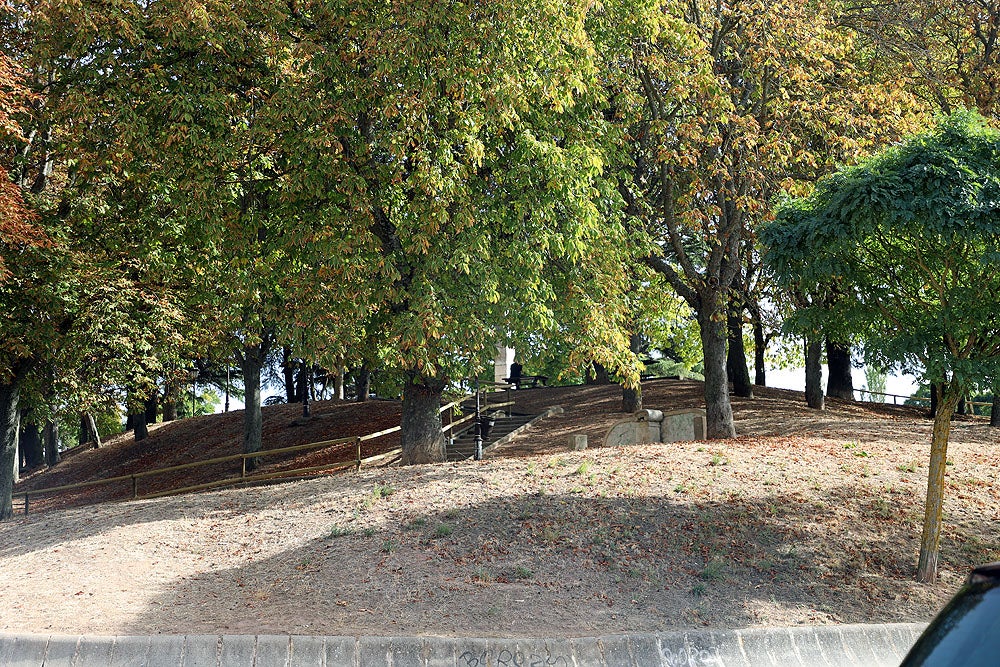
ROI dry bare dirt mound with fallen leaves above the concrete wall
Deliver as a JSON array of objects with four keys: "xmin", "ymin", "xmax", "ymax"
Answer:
[{"xmin": 0, "ymin": 381, "xmax": 1000, "ymax": 636}]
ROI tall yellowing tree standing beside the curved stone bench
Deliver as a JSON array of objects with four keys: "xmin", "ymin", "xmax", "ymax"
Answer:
[{"xmin": 594, "ymin": 0, "xmax": 920, "ymax": 437}]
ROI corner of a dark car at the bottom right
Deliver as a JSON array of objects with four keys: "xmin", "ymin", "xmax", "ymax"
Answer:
[{"xmin": 900, "ymin": 563, "xmax": 1000, "ymax": 667}]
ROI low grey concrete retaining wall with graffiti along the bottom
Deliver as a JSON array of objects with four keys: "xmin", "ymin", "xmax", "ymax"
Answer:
[{"xmin": 0, "ymin": 624, "xmax": 924, "ymax": 667}]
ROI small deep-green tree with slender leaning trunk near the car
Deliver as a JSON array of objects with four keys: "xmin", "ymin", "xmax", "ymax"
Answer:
[{"xmin": 764, "ymin": 113, "xmax": 1000, "ymax": 582}]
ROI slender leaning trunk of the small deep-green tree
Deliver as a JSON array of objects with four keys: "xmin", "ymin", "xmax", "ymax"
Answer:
[{"xmin": 917, "ymin": 382, "xmax": 962, "ymax": 584}]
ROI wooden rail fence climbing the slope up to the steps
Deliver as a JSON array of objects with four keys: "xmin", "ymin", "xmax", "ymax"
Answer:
[{"xmin": 14, "ymin": 385, "xmax": 514, "ymax": 514}]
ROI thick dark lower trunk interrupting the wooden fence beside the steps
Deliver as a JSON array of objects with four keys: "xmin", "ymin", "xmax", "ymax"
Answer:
[{"xmin": 400, "ymin": 377, "xmax": 446, "ymax": 465}]
